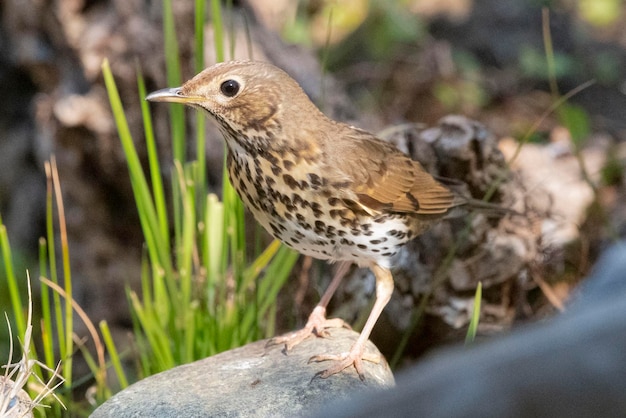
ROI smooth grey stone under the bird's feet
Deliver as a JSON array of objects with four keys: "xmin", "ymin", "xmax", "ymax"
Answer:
[{"xmin": 91, "ymin": 329, "xmax": 394, "ymax": 418}]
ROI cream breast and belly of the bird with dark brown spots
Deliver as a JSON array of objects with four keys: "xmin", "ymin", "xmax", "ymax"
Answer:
[{"xmin": 228, "ymin": 150, "xmax": 415, "ymax": 265}]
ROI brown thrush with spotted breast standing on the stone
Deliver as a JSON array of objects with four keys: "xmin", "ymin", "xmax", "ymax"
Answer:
[{"xmin": 146, "ymin": 60, "xmax": 467, "ymax": 380}]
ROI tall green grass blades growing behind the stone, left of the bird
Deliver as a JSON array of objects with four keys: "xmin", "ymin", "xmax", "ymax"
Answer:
[{"xmin": 0, "ymin": 0, "xmax": 298, "ymax": 416}]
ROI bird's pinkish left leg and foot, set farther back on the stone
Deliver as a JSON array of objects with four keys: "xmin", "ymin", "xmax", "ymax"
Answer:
[{"xmin": 267, "ymin": 261, "xmax": 350, "ymax": 351}]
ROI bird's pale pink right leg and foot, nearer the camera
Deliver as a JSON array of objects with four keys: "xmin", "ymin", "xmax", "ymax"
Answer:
[{"xmin": 309, "ymin": 264, "xmax": 393, "ymax": 380}]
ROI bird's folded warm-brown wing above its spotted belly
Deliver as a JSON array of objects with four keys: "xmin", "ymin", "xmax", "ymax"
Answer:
[{"xmin": 326, "ymin": 127, "xmax": 454, "ymax": 215}]
